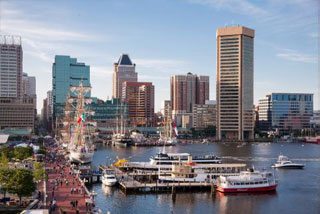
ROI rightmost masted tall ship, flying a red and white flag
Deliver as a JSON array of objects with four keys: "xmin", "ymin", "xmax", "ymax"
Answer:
[{"xmin": 158, "ymin": 117, "xmax": 178, "ymax": 145}]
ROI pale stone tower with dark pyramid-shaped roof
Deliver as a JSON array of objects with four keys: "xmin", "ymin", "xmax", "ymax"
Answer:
[{"xmin": 112, "ymin": 54, "xmax": 138, "ymax": 99}]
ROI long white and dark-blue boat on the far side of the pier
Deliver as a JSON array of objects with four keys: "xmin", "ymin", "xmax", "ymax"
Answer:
[{"xmin": 150, "ymin": 151, "xmax": 222, "ymax": 165}]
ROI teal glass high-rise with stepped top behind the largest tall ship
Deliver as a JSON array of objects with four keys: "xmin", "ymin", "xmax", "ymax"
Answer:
[{"xmin": 52, "ymin": 55, "xmax": 90, "ymax": 120}]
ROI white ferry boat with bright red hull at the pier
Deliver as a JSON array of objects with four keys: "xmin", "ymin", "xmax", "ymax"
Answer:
[{"xmin": 217, "ymin": 169, "xmax": 278, "ymax": 193}]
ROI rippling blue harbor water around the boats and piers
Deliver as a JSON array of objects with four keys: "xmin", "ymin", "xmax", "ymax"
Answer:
[{"xmin": 92, "ymin": 143, "xmax": 320, "ymax": 214}]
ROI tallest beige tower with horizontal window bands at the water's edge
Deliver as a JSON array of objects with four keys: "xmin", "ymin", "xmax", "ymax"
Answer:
[{"xmin": 217, "ymin": 26, "xmax": 254, "ymax": 140}]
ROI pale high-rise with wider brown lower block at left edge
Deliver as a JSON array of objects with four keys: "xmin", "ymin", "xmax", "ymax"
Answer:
[{"xmin": 0, "ymin": 36, "xmax": 36, "ymax": 129}]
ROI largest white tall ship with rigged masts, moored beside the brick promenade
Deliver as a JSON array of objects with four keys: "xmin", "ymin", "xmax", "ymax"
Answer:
[{"xmin": 67, "ymin": 81, "xmax": 96, "ymax": 164}]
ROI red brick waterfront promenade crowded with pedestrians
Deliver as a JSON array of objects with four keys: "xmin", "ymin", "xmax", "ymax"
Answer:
[{"xmin": 46, "ymin": 145, "xmax": 91, "ymax": 214}]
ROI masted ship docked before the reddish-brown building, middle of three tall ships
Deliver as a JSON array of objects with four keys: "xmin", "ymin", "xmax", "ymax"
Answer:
[{"xmin": 112, "ymin": 103, "xmax": 132, "ymax": 147}]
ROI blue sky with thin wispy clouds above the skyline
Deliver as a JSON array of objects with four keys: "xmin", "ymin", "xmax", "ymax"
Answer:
[{"xmin": 0, "ymin": 0, "xmax": 320, "ymax": 113}]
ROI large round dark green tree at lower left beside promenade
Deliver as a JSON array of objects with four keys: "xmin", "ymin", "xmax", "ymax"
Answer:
[{"xmin": 8, "ymin": 169, "xmax": 36, "ymax": 204}]
